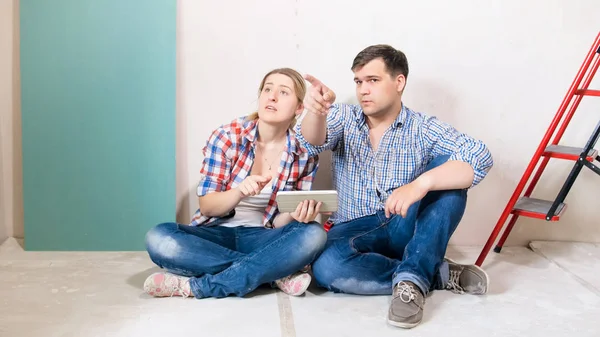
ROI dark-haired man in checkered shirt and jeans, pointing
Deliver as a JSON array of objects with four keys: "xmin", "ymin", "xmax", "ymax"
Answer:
[{"xmin": 297, "ymin": 45, "xmax": 493, "ymax": 328}]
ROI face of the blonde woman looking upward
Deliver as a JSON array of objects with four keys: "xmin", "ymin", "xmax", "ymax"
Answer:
[{"xmin": 258, "ymin": 74, "xmax": 303, "ymax": 128}]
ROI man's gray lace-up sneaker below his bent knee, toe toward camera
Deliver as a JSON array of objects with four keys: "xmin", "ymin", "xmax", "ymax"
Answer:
[{"xmin": 387, "ymin": 281, "xmax": 425, "ymax": 328}]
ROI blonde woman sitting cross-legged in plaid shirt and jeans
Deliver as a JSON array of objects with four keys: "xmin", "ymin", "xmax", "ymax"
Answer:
[{"xmin": 144, "ymin": 68, "xmax": 326, "ymax": 298}]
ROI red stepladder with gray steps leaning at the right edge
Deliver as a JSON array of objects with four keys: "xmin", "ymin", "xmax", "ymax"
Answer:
[{"xmin": 475, "ymin": 33, "xmax": 600, "ymax": 266}]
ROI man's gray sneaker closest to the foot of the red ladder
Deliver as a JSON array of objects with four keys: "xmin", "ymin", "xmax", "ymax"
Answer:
[{"xmin": 445, "ymin": 258, "xmax": 490, "ymax": 295}]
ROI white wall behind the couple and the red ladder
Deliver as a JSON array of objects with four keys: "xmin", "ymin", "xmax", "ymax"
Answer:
[{"xmin": 177, "ymin": 0, "xmax": 600, "ymax": 245}]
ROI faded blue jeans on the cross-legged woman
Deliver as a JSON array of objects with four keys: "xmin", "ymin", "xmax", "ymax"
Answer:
[{"xmin": 146, "ymin": 221, "xmax": 327, "ymax": 298}]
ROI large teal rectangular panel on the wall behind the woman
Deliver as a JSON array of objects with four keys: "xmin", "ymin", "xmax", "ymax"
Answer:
[{"xmin": 20, "ymin": 0, "xmax": 176, "ymax": 250}]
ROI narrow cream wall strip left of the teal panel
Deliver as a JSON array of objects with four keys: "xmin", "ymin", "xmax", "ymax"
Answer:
[{"xmin": 0, "ymin": 0, "xmax": 23, "ymax": 241}]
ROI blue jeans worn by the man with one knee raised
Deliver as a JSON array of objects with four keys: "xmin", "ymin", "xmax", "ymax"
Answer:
[{"xmin": 312, "ymin": 156, "xmax": 467, "ymax": 295}]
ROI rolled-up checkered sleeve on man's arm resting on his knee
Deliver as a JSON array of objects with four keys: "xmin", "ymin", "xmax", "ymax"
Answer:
[{"xmin": 423, "ymin": 117, "xmax": 494, "ymax": 187}]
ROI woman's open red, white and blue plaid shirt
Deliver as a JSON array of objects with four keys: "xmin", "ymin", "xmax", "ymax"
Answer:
[{"xmin": 190, "ymin": 117, "xmax": 319, "ymax": 227}]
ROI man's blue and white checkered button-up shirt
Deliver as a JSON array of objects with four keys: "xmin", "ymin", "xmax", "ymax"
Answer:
[{"xmin": 296, "ymin": 104, "xmax": 493, "ymax": 223}]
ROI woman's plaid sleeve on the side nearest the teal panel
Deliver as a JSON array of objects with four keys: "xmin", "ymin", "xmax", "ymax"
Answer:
[{"xmin": 196, "ymin": 129, "xmax": 232, "ymax": 197}]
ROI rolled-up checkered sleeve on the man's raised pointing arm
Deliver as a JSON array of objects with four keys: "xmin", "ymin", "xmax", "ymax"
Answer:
[{"xmin": 295, "ymin": 104, "xmax": 345, "ymax": 157}]
